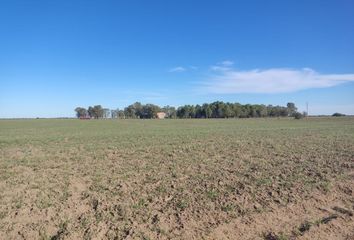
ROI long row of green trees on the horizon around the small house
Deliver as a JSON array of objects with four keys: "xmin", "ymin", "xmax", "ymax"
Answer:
[{"xmin": 75, "ymin": 101, "xmax": 305, "ymax": 119}]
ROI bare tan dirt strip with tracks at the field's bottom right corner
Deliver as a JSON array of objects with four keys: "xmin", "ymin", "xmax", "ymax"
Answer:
[{"xmin": 207, "ymin": 180, "xmax": 354, "ymax": 240}]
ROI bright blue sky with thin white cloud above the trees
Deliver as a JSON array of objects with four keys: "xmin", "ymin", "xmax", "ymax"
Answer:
[{"xmin": 0, "ymin": 0, "xmax": 354, "ymax": 118}]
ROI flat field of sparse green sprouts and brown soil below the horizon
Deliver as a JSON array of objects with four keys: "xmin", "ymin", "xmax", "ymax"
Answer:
[{"xmin": 0, "ymin": 117, "xmax": 354, "ymax": 239}]
